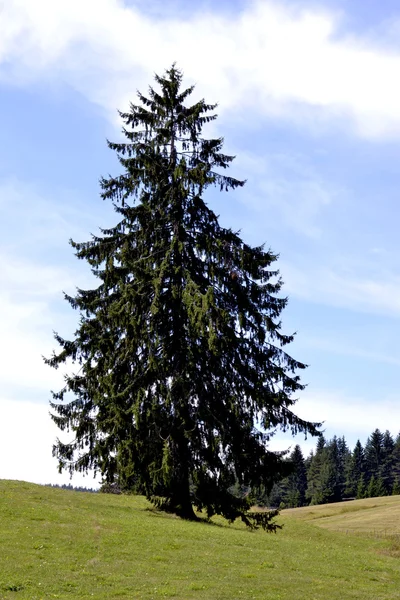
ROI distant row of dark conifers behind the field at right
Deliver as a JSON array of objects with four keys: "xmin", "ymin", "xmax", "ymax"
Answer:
[{"xmin": 256, "ymin": 429, "xmax": 400, "ymax": 508}]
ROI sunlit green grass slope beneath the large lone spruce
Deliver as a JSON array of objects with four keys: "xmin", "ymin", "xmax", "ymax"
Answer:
[{"xmin": 0, "ymin": 481, "xmax": 400, "ymax": 600}]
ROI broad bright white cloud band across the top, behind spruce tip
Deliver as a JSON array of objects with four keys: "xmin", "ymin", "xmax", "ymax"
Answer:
[{"xmin": 0, "ymin": 0, "xmax": 400, "ymax": 137}]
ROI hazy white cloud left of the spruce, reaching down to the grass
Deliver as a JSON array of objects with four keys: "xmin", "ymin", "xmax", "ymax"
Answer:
[{"xmin": 0, "ymin": 181, "xmax": 102, "ymax": 487}]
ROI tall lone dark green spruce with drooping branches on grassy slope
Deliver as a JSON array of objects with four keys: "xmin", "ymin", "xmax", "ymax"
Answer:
[{"xmin": 46, "ymin": 66, "xmax": 318, "ymax": 527}]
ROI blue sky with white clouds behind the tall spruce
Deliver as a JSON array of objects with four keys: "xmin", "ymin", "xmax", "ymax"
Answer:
[{"xmin": 0, "ymin": 0, "xmax": 400, "ymax": 487}]
